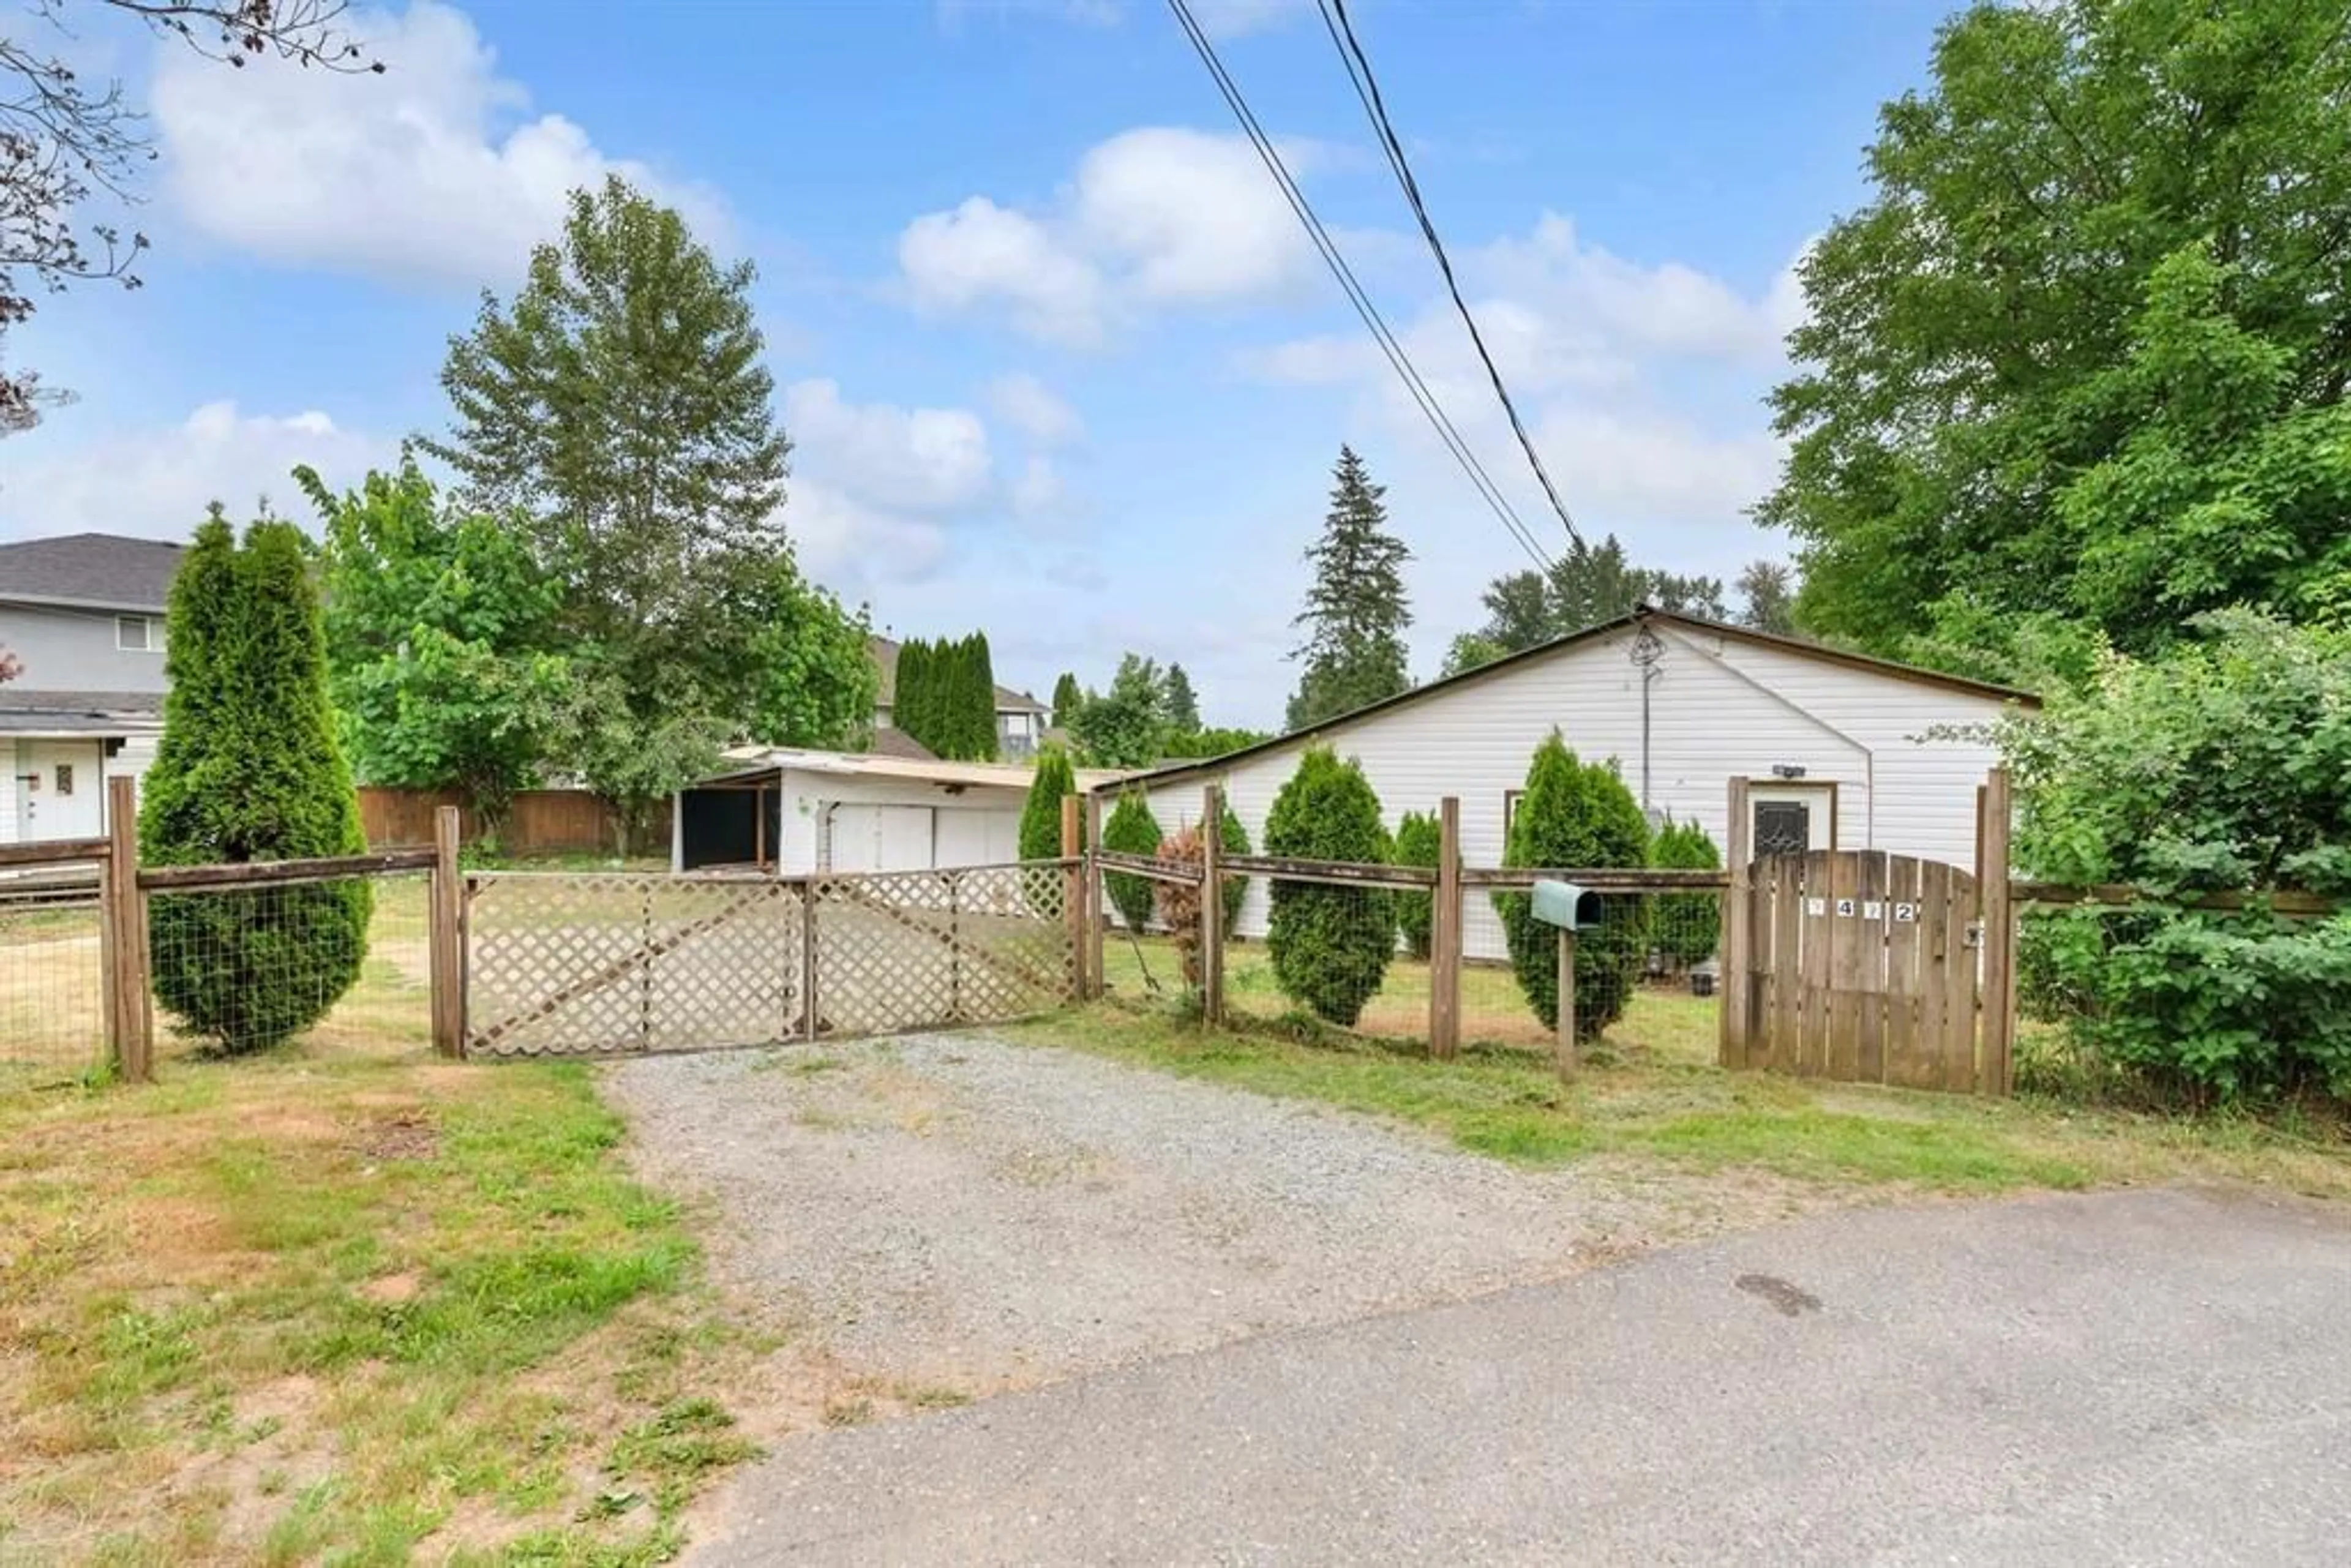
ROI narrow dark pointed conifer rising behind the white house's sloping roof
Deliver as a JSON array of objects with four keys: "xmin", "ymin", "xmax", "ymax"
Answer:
[{"xmin": 1286, "ymin": 447, "xmax": 1413, "ymax": 729}]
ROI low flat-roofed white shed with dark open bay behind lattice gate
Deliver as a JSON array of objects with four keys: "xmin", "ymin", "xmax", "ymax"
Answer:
[{"xmin": 670, "ymin": 748, "xmax": 1119, "ymax": 877}]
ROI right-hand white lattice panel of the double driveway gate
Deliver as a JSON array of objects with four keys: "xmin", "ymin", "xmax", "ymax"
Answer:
[{"xmin": 811, "ymin": 865, "xmax": 1077, "ymax": 1034}]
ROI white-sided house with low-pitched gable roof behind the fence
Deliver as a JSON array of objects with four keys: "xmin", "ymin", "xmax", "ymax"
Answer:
[{"xmin": 1109, "ymin": 609, "xmax": 2036, "ymax": 957}]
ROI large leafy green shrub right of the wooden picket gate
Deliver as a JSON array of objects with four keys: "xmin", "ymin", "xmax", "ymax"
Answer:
[{"xmin": 2003, "ymin": 611, "xmax": 2351, "ymax": 1100}]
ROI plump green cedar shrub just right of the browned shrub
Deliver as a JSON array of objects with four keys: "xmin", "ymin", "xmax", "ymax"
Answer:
[{"xmin": 1265, "ymin": 745, "xmax": 1397, "ymax": 1025}]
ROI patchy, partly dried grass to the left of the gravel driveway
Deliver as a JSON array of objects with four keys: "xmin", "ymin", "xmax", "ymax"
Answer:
[{"xmin": 0, "ymin": 888, "xmax": 764, "ymax": 1566}]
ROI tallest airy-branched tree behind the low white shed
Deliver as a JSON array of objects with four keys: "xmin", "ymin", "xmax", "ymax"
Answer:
[{"xmin": 423, "ymin": 176, "xmax": 799, "ymax": 822}]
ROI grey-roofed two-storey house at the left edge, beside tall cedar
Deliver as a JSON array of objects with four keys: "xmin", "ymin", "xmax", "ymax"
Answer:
[{"xmin": 0, "ymin": 534, "xmax": 181, "ymax": 844}]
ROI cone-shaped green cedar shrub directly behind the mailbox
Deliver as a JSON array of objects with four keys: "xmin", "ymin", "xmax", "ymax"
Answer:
[{"xmin": 1493, "ymin": 729, "xmax": 1648, "ymax": 1039}]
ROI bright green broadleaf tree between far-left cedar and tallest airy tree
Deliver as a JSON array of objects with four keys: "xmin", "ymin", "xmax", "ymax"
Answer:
[{"xmin": 294, "ymin": 461, "xmax": 571, "ymax": 830}]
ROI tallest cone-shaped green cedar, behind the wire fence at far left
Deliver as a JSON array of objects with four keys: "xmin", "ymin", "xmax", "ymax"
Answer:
[{"xmin": 139, "ymin": 508, "xmax": 374, "ymax": 1051}]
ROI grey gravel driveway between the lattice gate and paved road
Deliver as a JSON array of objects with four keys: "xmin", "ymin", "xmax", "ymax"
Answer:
[{"xmin": 604, "ymin": 1034, "xmax": 1791, "ymax": 1392}]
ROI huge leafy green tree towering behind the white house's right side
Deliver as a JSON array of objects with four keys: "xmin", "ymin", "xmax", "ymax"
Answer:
[{"xmin": 1758, "ymin": 0, "xmax": 2351, "ymax": 675}]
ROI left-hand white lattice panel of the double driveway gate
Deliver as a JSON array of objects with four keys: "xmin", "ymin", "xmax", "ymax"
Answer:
[{"xmin": 465, "ymin": 872, "xmax": 804, "ymax": 1056}]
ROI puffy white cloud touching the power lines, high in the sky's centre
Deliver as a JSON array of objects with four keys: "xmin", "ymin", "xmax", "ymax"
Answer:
[{"xmin": 898, "ymin": 127, "xmax": 1321, "ymax": 345}]
